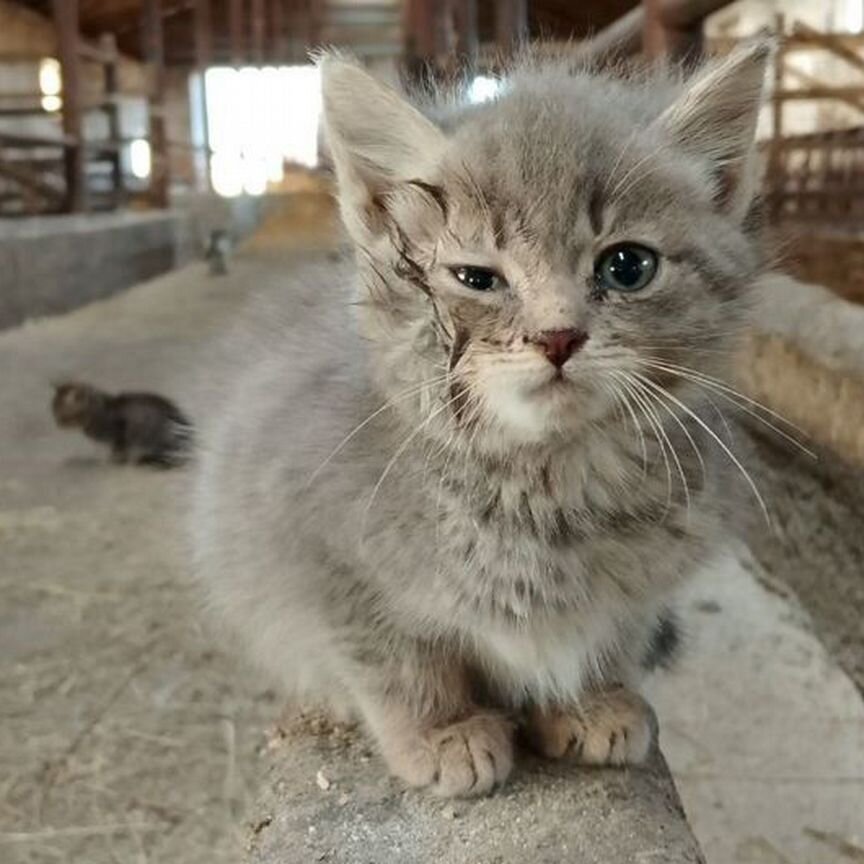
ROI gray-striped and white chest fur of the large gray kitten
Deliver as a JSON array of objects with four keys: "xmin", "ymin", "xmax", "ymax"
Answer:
[{"xmin": 402, "ymin": 442, "xmax": 706, "ymax": 702}]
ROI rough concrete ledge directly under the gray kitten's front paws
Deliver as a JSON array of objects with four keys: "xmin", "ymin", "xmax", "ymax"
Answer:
[{"xmin": 246, "ymin": 717, "xmax": 704, "ymax": 864}]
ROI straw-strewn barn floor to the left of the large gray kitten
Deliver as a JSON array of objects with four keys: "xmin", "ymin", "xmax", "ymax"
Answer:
[{"xmin": 0, "ymin": 198, "xmax": 333, "ymax": 864}]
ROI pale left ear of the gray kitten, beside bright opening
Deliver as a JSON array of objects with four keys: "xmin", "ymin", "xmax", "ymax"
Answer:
[{"xmin": 319, "ymin": 54, "xmax": 447, "ymax": 242}]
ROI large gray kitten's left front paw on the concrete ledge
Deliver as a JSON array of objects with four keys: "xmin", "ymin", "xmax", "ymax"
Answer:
[{"xmin": 390, "ymin": 714, "xmax": 513, "ymax": 798}]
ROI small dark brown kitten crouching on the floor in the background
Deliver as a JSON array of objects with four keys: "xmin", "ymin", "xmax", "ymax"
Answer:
[{"xmin": 51, "ymin": 381, "xmax": 192, "ymax": 468}]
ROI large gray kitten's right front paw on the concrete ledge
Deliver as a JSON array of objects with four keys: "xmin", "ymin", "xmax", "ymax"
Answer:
[{"xmin": 525, "ymin": 687, "xmax": 656, "ymax": 765}]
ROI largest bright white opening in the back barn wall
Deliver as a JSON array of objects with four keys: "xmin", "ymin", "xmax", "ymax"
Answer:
[{"xmin": 204, "ymin": 66, "xmax": 321, "ymax": 197}]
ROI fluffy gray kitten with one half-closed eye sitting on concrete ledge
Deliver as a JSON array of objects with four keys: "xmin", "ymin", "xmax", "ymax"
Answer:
[{"xmin": 194, "ymin": 44, "xmax": 770, "ymax": 795}]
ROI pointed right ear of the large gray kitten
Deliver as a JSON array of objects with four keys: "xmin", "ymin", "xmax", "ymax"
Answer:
[{"xmin": 658, "ymin": 39, "xmax": 774, "ymax": 219}]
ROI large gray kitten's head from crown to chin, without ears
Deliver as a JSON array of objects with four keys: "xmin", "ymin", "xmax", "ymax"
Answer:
[{"xmin": 326, "ymin": 46, "xmax": 761, "ymax": 446}]
